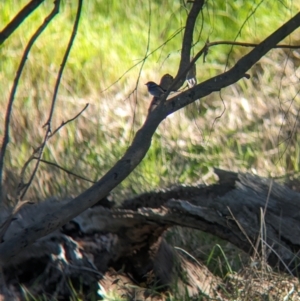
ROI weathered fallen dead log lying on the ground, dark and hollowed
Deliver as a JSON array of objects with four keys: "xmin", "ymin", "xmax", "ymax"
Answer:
[{"xmin": 0, "ymin": 170, "xmax": 300, "ymax": 297}]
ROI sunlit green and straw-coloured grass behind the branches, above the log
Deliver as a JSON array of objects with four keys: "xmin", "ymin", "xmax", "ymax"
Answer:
[{"xmin": 0, "ymin": 2, "xmax": 300, "ymax": 200}]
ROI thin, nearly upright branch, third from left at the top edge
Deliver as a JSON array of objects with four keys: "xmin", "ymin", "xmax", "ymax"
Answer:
[{"xmin": 20, "ymin": 0, "xmax": 83, "ymax": 199}]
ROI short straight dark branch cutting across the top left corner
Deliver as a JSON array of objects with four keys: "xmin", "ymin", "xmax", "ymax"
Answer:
[{"xmin": 0, "ymin": 0, "xmax": 44, "ymax": 45}]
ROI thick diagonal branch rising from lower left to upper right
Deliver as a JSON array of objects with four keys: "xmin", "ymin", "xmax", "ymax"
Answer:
[{"xmin": 0, "ymin": 13, "xmax": 300, "ymax": 265}]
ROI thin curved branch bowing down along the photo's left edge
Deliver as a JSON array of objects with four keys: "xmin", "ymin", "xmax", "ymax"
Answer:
[{"xmin": 0, "ymin": 0, "xmax": 60, "ymax": 201}]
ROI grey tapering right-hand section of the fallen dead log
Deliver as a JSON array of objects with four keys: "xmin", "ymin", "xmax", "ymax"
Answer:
[{"xmin": 122, "ymin": 169, "xmax": 300, "ymax": 274}]
